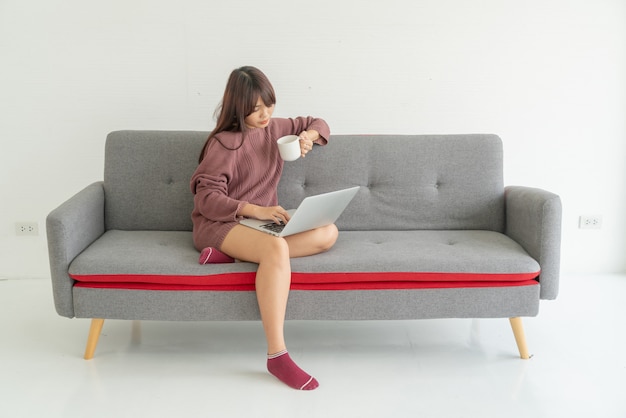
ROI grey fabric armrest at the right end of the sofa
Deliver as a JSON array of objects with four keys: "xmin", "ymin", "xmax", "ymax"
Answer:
[{"xmin": 504, "ymin": 186, "xmax": 562, "ymax": 299}]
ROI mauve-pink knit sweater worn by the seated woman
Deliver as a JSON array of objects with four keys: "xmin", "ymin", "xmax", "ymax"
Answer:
[{"xmin": 191, "ymin": 117, "xmax": 330, "ymax": 250}]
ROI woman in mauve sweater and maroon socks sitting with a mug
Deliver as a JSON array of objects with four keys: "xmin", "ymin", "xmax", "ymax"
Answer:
[{"xmin": 191, "ymin": 67, "xmax": 338, "ymax": 390}]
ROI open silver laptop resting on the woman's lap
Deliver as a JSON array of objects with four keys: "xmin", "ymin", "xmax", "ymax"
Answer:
[{"xmin": 239, "ymin": 186, "xmax": 360, "ymax": 237}]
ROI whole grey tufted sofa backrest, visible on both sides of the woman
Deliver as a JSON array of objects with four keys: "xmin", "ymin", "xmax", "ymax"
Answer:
[{"xmin": 104, "ymin": 131, "xmax": 504, "ymax": 232}]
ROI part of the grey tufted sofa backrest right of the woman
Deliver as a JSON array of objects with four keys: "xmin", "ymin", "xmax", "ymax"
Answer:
[{"xmin": 278, "ymin": 134, "xmax": 504, "ymax": 232}]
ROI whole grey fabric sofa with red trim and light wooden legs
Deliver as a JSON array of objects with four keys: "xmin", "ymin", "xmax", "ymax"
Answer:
[{"xmin": 47, "ymin": 131, "xmax": 561, "ymax": 359}]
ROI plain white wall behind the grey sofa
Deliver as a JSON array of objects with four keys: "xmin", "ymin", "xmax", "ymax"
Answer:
[{"xmin": 0, "ymin": 0, "xmax": 626, "ymax": 278}]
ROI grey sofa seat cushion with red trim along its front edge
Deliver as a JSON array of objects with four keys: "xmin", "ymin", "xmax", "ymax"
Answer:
[{"xmin": 69, "ymin": 230, "xmax": 539, "ymax": 290}]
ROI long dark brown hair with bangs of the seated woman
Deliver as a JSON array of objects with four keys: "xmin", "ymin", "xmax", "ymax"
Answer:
[{"xmin": 198, "ymin": 66, "xmax": 276, "ymax": 163}]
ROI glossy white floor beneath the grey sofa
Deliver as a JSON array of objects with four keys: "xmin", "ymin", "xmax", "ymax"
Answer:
[{"xmin": 0, "ymin": 276, "xmax": 626, "ymax": 418}]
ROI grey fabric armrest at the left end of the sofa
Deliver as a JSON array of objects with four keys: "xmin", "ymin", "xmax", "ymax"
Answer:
[{"xmin": 46, "ymin": 182, "xmax": 104, "ymax": 318}]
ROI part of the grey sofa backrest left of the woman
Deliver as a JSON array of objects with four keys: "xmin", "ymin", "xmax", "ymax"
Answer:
[{"xmin": 104, "ymin": 131, "xmax": 209, "ymax": 231}]
